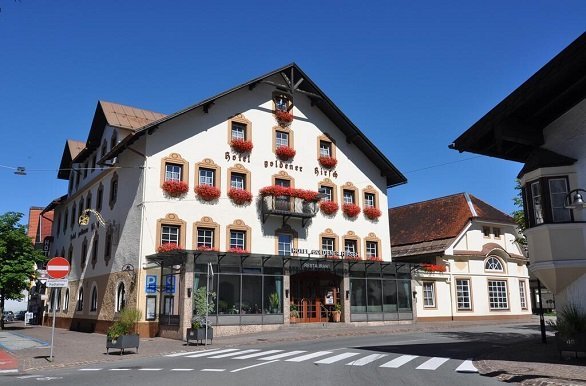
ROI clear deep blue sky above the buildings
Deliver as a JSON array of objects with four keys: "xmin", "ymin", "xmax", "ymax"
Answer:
[{"xmin": 0, "ymin": 0, "xmax": 586, "ymax": 223}]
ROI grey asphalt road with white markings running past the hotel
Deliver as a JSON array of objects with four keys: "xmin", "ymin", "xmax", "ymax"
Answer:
[{"xmin": 0, "ymin": 326, "xmax": 535, "ymax": 386}]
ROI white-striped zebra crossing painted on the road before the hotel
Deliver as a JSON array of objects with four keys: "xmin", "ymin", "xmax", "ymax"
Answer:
[{"xmin": 165, "ymin": 348, "xmax": 478, "ymax": 373}]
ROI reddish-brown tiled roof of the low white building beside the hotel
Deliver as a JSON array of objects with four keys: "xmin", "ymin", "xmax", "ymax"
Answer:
[{"xmin": 389, "ymin": 193, "xmax": 515, "ymax": 255}]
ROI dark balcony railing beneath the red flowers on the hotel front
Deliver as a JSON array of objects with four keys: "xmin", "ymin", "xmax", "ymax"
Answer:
[{"xmin": 261, "ymin": 196, "xmax": 318, "ymax": 226}]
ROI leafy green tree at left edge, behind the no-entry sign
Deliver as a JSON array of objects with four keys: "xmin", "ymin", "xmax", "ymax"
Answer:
[{"xmin": 0, "ymin": 212, "xmax": 45, "ymax": 330}]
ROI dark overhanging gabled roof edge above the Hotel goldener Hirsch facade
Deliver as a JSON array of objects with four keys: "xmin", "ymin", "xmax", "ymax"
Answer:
[{"xmin": 100, "ymin": 63, "xmax": 407, "ymax": 187}]
